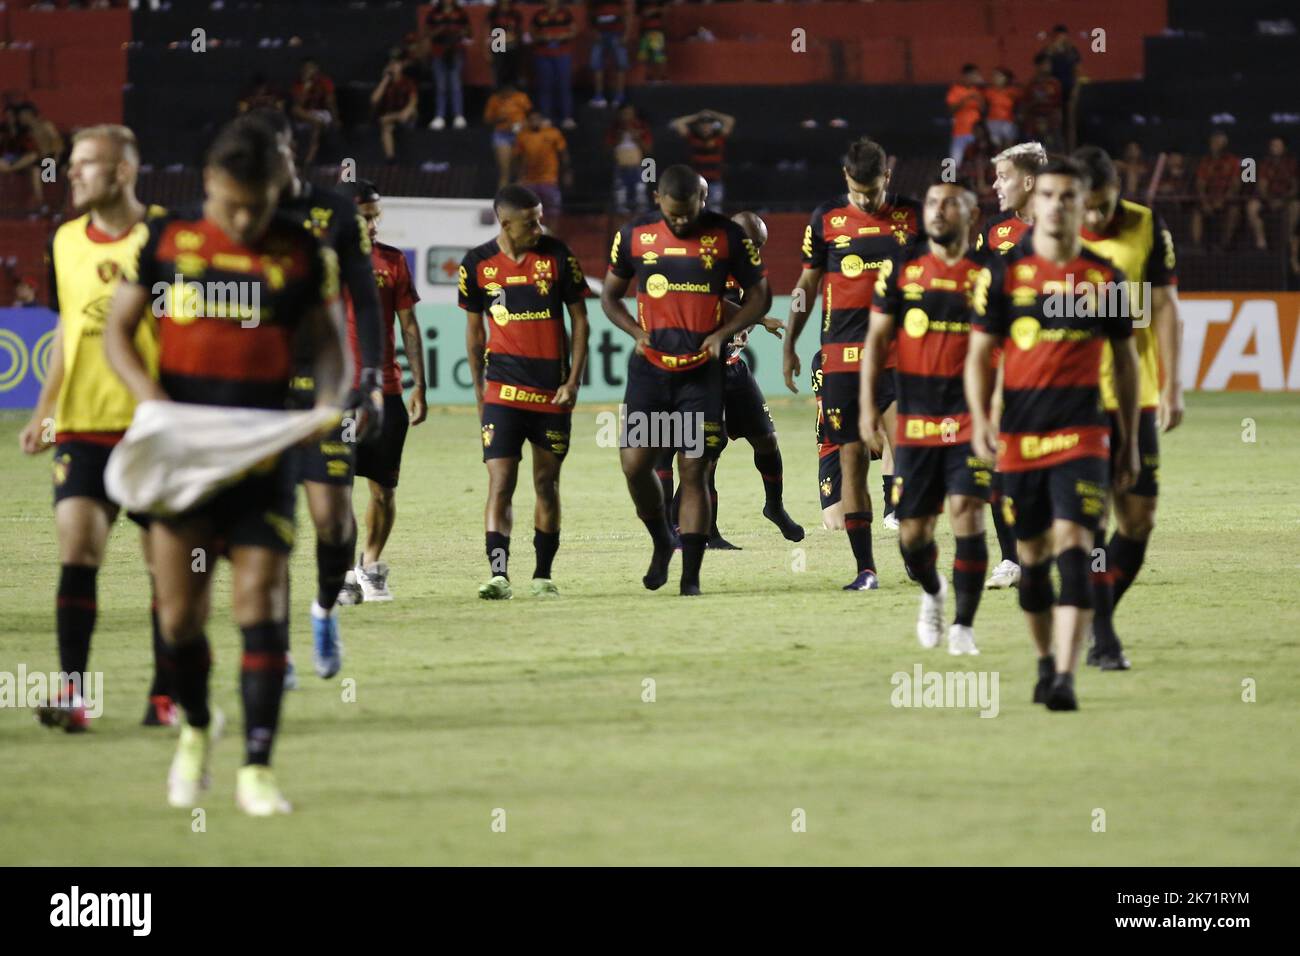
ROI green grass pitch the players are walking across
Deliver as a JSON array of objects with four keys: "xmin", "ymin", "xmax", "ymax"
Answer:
[{"xmin": 0, "ymin": 394, "xmax": 1300, "ymax": 865}]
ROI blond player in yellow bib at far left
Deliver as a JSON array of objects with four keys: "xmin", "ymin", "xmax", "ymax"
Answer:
[{"xmin": 18, "ymin": 125, "xmax": 177, "ymax": 732}]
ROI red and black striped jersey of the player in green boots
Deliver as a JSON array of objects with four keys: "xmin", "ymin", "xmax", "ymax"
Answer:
[{"xmin": 458, "ymin": 235, "xmax": 588, "ymax": 411}]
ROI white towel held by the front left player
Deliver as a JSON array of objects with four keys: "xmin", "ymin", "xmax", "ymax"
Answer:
[{"xmin": 104, "ymin": 401, "xmax": 339, "ymax": 515}]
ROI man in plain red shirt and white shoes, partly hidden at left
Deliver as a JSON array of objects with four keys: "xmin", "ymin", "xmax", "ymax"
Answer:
[{"xmin": 345, "ymin": 179, "xmax": 429, "ymax": 601}]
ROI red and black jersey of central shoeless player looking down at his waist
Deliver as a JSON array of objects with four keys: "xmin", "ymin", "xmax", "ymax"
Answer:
[{"xmin": 610, "ymin": 209, "xmax": 767, "ymax": 371}]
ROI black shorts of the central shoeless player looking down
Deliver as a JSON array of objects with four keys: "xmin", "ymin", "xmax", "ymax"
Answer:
[{"xmin": 619, "ymin": 354, "xmax": 727, "ymax": 459}]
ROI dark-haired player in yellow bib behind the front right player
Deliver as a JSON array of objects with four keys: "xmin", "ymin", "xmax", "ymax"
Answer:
[{"xmin": 1074, "ymin": 146, "xmax": 1183, "ymax": 670}]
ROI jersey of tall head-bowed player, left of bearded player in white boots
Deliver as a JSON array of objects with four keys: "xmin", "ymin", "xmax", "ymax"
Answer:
[{"xmin": 802, "ymin": 195, "xmax": 920, "ymax": 373}]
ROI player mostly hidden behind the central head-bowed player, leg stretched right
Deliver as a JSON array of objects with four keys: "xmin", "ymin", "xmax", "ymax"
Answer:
[{"xmin": 655, "ymin": 212, "xmax": 803, "ymax": 551}]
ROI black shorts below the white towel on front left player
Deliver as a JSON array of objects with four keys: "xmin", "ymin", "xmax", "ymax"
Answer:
[{"xmin": 153, "ymin": 453, "xmax": 298, "ymax": 554}]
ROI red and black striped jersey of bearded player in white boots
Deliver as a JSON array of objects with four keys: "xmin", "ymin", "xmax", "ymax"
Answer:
[{"xmin": 871, "ymin": 241, "xmax": 989, "ymax": 445}]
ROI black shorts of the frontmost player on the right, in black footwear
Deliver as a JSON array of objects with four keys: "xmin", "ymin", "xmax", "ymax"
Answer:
[{"xmin": 1001, "ymin": 458, "xmax": 1110, "ymax": 541}]
